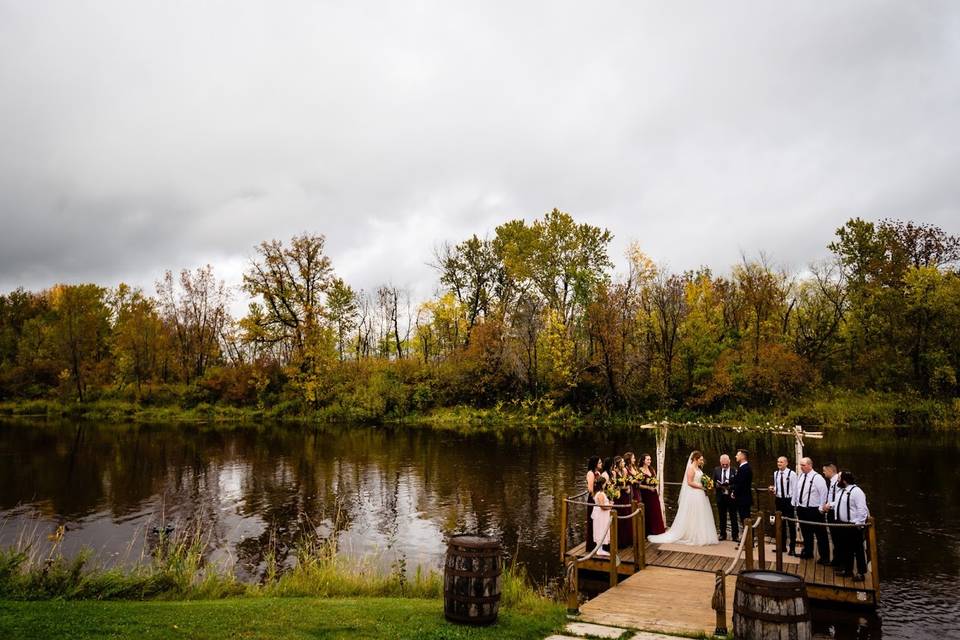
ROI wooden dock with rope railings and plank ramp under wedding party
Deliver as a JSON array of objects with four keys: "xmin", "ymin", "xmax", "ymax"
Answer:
[{"xmin": 560, "ymin": 496, "xmax": 880, "ymax": 634}]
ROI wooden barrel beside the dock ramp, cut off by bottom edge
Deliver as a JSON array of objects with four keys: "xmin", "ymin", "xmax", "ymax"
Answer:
[{"xmin": 733, "ymin": 571, "xmax": 813, "ymax": 640}]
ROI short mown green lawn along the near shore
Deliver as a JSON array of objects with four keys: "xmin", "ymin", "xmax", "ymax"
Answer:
[{"xmin": 0, "ymin": 598, "xmax": 564, "ymax": 640}]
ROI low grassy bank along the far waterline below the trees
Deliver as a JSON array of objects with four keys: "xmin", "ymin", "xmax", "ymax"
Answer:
[{"xmin": 0, "ymin": 390, "xmax": 960, "ymax": 430}]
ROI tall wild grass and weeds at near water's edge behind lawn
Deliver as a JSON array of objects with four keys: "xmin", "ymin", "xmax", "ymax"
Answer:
[{"xmin": 0, "ymin": 520, "xmax": 548, "ymax": 611}]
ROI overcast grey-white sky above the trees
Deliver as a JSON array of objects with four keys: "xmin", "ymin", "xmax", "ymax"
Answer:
[{"xmin": 0, "ymin": 0, "xmax": 960, "ymax": 308}]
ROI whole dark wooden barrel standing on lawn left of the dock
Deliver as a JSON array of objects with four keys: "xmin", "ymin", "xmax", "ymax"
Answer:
[{"xmin": 443, "ymin": 535, "xmax": 503, "ymax": 625}]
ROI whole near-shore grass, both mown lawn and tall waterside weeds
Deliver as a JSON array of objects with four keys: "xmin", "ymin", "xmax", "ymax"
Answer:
[{"xmin": 0, "ymin": 519, "xmax": 565, "ymax": 639}]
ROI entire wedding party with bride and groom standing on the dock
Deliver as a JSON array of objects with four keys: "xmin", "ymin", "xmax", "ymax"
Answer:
[{"xmin": 586, "ymin": 449, "xmax": 870, "ymax": 581}]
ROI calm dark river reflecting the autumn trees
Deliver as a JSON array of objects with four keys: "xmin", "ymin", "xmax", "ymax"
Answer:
[{"xmin": 0, "ymin": 422, "xmax": 960, "ymax": 638}]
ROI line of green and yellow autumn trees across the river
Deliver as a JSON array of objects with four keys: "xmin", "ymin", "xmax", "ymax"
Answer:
[{"xmin": 0, "ymin": 209, "xmax": 960, "ymax": 419}]
